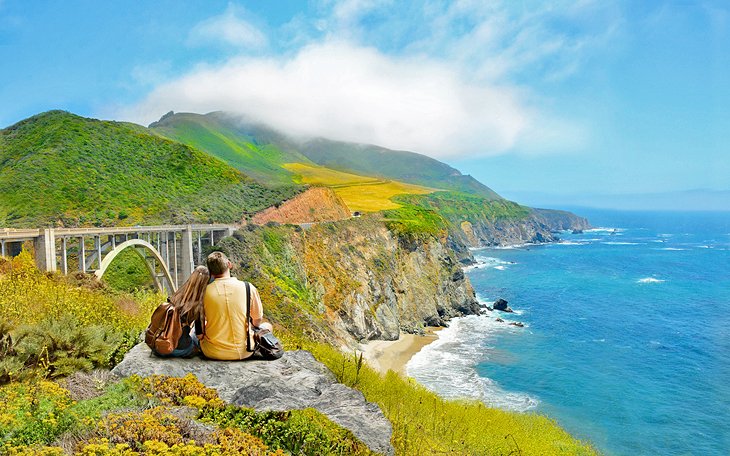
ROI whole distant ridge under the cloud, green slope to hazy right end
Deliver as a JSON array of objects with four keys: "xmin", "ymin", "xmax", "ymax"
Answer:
[{"xmin": 150, "ymin": 112, "xmax": 501, "ymax": 200}]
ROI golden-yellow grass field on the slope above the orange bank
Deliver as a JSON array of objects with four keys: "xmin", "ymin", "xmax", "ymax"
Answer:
[{"xmin": 285, "ymin": 163, "xmax": 436, "ymax": 212}]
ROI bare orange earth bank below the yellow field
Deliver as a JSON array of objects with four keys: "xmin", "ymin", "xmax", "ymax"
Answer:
[{"xmin": 249, "ymin": 187, "xmax": 351, "ymax": 225}]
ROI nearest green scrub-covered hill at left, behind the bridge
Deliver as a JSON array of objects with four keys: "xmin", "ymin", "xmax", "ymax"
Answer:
[{"xmin": 0, "ymin": 111, "xmax": 296, "ymax": 227}]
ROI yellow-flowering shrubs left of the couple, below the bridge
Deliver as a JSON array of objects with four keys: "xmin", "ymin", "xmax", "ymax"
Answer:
[{"xmin": 0, "ymin": 251, "xmax": 162, "ymax": 383}]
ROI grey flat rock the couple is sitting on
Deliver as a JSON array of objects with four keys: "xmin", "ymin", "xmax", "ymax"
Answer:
[{"xmin": 112, "ymin": 343, "xmax": 394, "ymax": 455}]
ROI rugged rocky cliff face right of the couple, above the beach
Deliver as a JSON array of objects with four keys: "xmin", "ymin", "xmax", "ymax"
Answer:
[{"xmin": 217, "ymin": 216, "xmax": 479, "ymax": 344}]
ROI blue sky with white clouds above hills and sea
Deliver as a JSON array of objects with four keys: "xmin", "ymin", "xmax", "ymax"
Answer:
[{"xmin": 0, "ymin": 0, "xmax": 730, "ymax": 208}]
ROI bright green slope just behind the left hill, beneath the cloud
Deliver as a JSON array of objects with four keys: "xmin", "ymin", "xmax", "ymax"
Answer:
[{"xmin": 150, "ymin": 113, "xmax": 311, "ymax": 186}]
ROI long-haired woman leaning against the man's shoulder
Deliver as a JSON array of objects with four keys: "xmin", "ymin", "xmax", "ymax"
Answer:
[{"xmin": 155, "ymin": 266, "xmax": 210, "ymax": 358}]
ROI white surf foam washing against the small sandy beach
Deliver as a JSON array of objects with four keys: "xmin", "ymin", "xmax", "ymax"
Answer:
[{"xmin": 406, "ymin": 315, "xmax": 538, "ymax": 412}]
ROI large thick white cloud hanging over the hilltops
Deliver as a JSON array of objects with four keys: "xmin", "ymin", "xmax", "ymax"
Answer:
[{"xmin": 123, "ymin": 43, "xmax": 534, "ymax": 157}]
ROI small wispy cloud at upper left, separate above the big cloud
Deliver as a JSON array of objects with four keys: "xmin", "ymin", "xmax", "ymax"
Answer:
[{"xmin": 188, "ymin": 4, "xmax": 268, "ymax": 49}]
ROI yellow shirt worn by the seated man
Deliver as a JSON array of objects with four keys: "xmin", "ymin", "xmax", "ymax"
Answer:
[{"xmin": 200, "ymin": 277, "xmax": 264, "ymax": 360}]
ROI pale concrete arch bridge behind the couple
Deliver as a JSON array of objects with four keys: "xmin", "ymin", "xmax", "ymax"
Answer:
[{"xmin": 0, "ymin": 225, "xmax": 237, "ymax": 293}]
